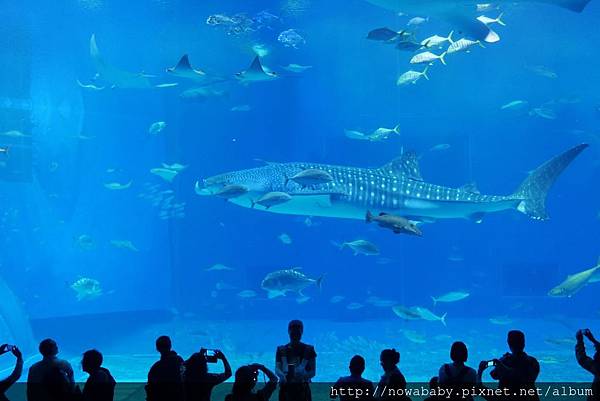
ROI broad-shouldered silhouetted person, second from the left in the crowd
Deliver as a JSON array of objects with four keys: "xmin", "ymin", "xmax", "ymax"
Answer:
[{"xmin": 27, "ymin": 338, "xmax": 78, "ymax": 401}]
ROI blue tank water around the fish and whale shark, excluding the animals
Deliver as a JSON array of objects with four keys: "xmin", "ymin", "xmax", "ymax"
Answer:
[{"xmin": 0, "ymin": 0, "xmax": 600, "ymax": 380}]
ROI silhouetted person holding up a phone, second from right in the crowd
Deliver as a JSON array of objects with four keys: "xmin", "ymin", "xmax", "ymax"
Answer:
[{"xmin": 479, "ymin": 330, "xmax": 540, "ymax": 401}]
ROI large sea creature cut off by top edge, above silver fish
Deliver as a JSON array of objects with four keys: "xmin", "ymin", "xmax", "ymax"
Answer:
[{"xmin": 366, "ymin": 0, "xmax": 590, "ymax": 42}]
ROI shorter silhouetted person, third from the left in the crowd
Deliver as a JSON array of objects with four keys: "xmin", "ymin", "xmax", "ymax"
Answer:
[{"xmin": 81, "ymin": 349, "xmax": 116, "ymax": 401}]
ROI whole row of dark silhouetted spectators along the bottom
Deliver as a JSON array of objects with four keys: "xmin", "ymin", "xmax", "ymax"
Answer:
[{"xmin": 0, "ymin": 320, "xmax": 600, "ymax": 401}]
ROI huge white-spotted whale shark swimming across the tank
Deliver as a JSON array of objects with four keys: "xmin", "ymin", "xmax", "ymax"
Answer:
[{"xmin": 195, "ymin": 144, "xmax": 588, "ymax": 223}]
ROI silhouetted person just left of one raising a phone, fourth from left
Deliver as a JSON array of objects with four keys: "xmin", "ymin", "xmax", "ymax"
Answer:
[{"xmin": 146, "ymin": 336, "xmax": 184, "ymax": 401}]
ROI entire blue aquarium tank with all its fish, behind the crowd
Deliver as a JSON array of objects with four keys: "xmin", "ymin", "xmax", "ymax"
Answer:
[{"xmin": 0, "ymin": 0, "xmax": 600, "ymax": 394}]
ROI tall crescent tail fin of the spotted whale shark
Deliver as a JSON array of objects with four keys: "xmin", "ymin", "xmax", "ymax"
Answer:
[{"xmin": 514, "ymin": 143, "xmax": 588, "ymax": 220}]
